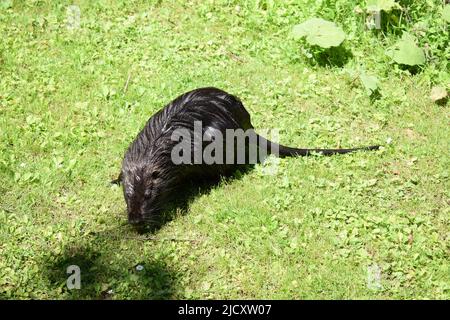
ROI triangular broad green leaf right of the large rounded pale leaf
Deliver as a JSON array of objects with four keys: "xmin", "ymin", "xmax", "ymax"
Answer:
[{"xmin": 391, "ymin": 32, "xmax": 425, "ymax": 66}]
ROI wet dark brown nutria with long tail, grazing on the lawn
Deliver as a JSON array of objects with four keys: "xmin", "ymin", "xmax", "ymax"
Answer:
[{"xmin": 115, "ymin": 88, "xmax": 379, "ymax": 224}]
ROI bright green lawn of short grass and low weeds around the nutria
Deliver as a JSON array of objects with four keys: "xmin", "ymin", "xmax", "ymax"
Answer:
[{"xmin": 0, "ymin": 0, "xmax": 450, "ymax": 299}]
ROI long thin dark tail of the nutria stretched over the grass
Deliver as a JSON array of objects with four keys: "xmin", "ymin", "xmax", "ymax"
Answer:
[{"xmin": 258, "ymin": 135, "xmax": 380, "ymax": 158}]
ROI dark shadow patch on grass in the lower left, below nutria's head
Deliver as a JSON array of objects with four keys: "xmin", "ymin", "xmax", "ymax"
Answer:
[{"xmin": 42, "ymin": 240, "xmax": 176, "ymax": 300}]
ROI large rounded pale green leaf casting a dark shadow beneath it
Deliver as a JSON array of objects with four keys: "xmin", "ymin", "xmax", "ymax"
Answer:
[{"xmin": 292, "ymin": 18, "xmax": 345, "ymax": 48}]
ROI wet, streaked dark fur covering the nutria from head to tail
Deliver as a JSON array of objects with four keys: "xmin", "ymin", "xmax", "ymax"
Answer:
[{"xmin": 115, "ymin": 88, "xmax": 378, "ymax": 224}]
